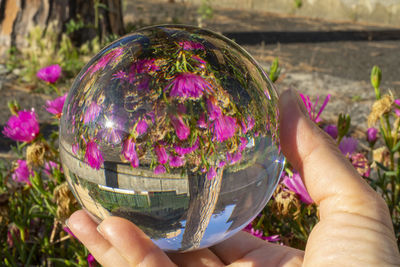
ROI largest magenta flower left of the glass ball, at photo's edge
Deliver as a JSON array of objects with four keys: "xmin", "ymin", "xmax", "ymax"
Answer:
[{"xmin": 3, "ymin": 109, "xmax": 39, "ymax": 142}]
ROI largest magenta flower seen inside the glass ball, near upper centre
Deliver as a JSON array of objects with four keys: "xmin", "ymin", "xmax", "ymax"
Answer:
[{"xmin": 164, "ymin": 73, "xmax": 212, "ymax": 99}]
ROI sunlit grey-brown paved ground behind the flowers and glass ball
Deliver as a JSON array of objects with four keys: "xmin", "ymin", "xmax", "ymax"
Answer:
[{"xmin": 0, "ymin": 0, "xmax": 400, "ymax": 156}]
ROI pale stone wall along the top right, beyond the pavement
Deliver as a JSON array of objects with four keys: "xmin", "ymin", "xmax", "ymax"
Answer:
[{"xmin": 186, "ymin": 0, "xmax": 400, "ymax": 27}]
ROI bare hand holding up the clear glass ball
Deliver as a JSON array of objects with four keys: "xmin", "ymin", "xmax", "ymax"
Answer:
[{"xmin": 68, "ymin": 90, "xmax": 400, "ymax": 267}]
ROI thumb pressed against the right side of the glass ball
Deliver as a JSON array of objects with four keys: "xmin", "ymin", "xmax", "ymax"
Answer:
[{"xmin": 279, "ymin": 90, "xmax": 392, "ymax": 224}]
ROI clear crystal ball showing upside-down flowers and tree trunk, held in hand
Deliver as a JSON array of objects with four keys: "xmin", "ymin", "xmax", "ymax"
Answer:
[{"xmin": 59, "ymin": 25, "xmax": 284, "ymax": 251}]
